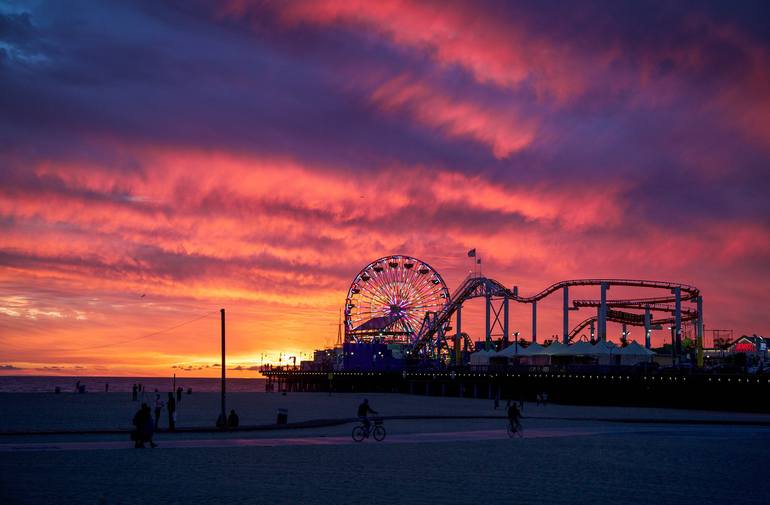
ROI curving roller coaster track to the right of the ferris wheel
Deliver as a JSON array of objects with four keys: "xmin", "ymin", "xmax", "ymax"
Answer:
[{"xmin": 414, "ymin": 275, "xmax": 700, "ymax": 351}]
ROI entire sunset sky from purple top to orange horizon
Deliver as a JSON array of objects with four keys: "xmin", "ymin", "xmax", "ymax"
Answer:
[{"xmin": 0, "ymin": 0, "xmax": 770, "ymax": 377}]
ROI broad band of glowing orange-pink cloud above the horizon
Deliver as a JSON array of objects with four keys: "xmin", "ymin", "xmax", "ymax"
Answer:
[{"xmin": 0, "ymin": 145, "xmax": 770, "ymax": 374}]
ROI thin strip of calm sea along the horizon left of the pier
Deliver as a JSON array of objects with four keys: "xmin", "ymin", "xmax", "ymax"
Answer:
[{"xmin": 0, "ymin": 376, "xmax": 265, "ymax": 393}]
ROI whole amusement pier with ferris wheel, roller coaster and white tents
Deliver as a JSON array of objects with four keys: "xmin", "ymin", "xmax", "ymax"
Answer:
[{"xmin": 261, "ymin": 254, "xmax": 770, "ymax": 412}]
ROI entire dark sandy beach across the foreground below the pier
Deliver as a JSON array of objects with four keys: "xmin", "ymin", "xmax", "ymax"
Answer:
[{"xmin": 0, "ymin": 393, "xmax": 770, "ymax": 504}]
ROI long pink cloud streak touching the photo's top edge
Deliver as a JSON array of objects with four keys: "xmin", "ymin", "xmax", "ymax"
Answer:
[{"xmin": 270, "ymin": 0, "xmax": 592, "ymax": 99}]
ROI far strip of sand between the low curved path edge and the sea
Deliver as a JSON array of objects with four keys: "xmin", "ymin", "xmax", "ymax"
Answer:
[{"xmin": 0, "ymin": 393, "xmax": 770, "ymax": 432}]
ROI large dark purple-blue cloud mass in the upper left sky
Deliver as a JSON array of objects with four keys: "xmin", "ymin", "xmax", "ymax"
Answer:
[{"xmin": 0, "ymin": 0, "xmax": 492, "ymax": 171}]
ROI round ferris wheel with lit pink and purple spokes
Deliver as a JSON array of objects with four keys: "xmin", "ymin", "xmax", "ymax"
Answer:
[{"xmin": 345, "ymin": 255, "xmax": 449, "ymax": 343}]
